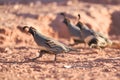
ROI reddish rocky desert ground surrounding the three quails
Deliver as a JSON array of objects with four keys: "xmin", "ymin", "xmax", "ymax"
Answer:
[{"xmin": 0, "ymin": 0, "xmax": 120, "ymax": 80}]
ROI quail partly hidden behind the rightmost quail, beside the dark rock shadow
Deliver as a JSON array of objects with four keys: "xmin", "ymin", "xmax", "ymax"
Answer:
[{"xmin": 60, "ymin": 12, "xmax": 84, "ymax": 44}]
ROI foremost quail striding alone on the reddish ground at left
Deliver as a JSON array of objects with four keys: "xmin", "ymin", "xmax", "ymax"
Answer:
[{"xmin": 23, "ymin": 26, "xmax": 75, "ymax": 61}]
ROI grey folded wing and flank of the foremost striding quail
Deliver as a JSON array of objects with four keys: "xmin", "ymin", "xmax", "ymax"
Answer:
[{"xmin": 35, "ymin": 32, "xmax": 72, "ymax": 53}]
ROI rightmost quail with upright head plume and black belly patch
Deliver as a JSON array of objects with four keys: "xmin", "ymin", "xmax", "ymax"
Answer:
[{"xmin": 76, "ymin": 14, "xmax": 112, "ymax": 49}]
